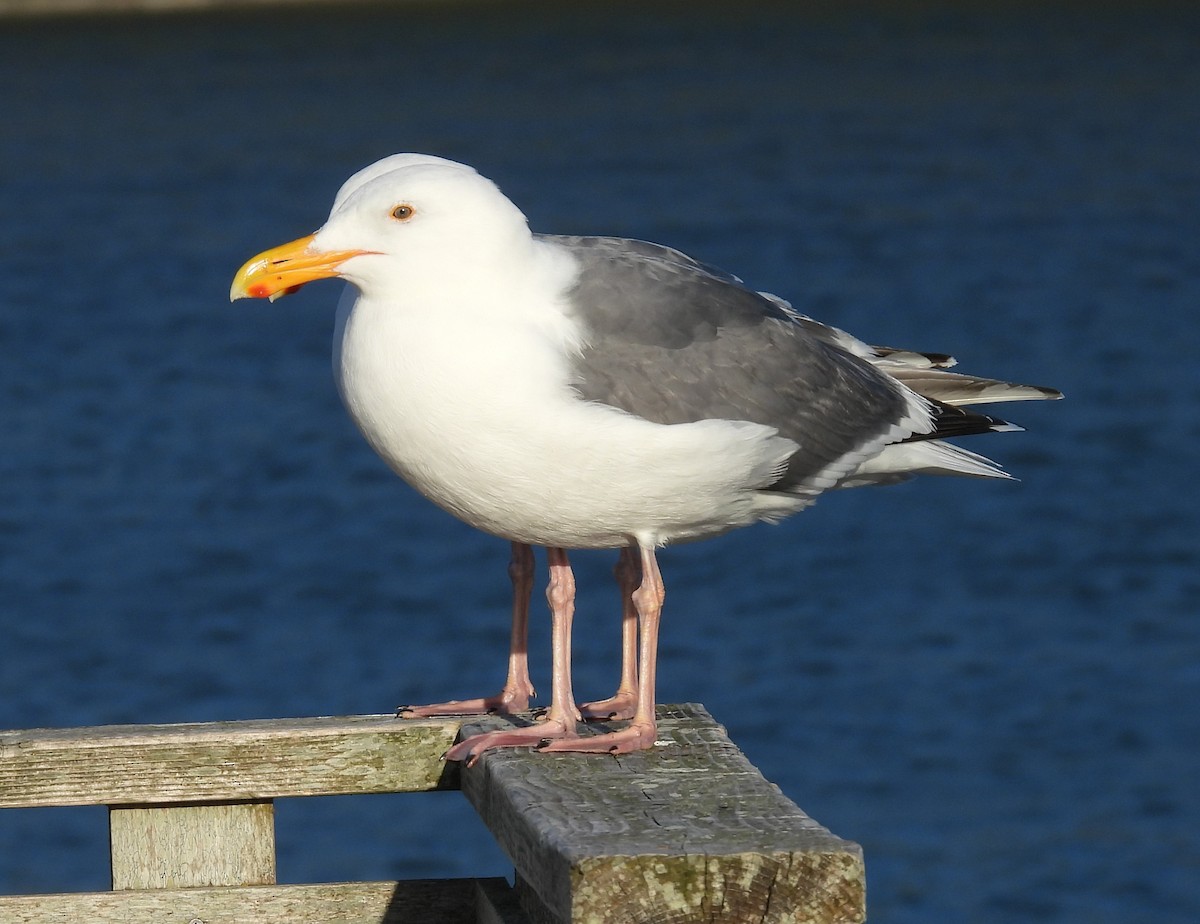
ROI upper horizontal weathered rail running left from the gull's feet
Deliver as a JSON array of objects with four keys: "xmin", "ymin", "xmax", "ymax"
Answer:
[{"xmin": 0, "ymin": 715, "xmax": 462, "ymax": 809}]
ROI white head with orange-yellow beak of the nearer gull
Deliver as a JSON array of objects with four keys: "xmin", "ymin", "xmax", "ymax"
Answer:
[{"xmin": 229, "ymin": 154, "xmax": 532, "ymax": 300}]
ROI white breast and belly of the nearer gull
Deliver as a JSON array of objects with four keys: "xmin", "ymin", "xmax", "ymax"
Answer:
[{"xmin": 334, "ymin": 291, "xmax": 803, "ymax": 548}]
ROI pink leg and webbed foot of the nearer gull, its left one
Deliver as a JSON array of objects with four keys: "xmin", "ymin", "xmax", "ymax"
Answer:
[{"xmin": 445, "ymin": 548, "xmax": 580, "ymax": 767}]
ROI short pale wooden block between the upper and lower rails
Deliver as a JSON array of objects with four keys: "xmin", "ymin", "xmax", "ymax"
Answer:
[{"xmin": 108, "ymin": 799, "xmax": 275, "ymax": 889}]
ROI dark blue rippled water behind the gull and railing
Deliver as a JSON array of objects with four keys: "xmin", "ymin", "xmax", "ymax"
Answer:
[{"xmin": 0, "ymin": 0, "xmax": 1200, "ymax": 924}]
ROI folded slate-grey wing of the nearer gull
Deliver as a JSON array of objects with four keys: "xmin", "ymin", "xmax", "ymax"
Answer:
[{"xmin": 540, "ymin": 235, "xmax": 912, "ymax": 490}]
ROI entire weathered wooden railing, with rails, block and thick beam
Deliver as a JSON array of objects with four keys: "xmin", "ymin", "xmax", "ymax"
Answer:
[{"xmin": 0, "ymin": 706, "xmax": 864, "ymax": 924}]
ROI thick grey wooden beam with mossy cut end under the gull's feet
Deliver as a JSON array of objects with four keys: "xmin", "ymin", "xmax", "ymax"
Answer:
[{"xmin": 462, "ymin": 706, "xmax": 865, "ymax": 924}]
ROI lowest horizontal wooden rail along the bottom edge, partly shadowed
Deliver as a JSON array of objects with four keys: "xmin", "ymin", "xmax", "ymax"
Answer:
[{"xmin": 0, "ymin": 880, "xmax": 524, "ymax": 924}]
